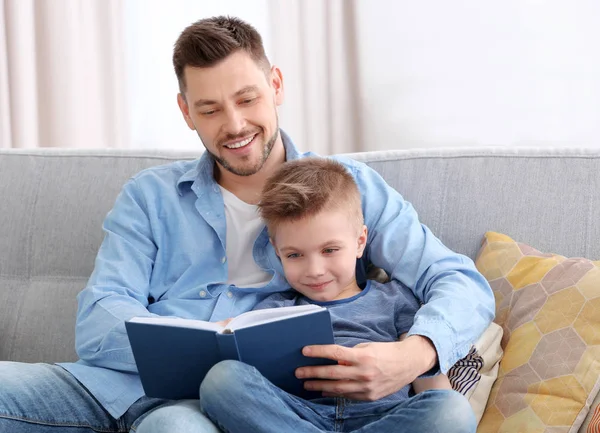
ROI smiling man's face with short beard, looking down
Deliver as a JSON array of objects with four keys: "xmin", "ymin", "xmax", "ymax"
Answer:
[{"xmin": 178, "ymin": 51, "xmax": 283, "ymax": 176}]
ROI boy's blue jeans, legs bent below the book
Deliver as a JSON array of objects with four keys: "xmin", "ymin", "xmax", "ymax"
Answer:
[{"xmin": 200, "ymin": 361, "xmax": 477, "ymax": 433}]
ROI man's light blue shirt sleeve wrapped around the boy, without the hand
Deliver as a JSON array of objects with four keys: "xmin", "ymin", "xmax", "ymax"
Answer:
[{"xmin": 352, "ymin": 159, "xmax": 495, "ymax": 373}]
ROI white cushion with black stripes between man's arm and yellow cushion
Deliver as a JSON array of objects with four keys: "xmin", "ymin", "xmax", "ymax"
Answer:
[{"xmin": 448, "ymin": 323, "xmax": 502, "ymax": 422}]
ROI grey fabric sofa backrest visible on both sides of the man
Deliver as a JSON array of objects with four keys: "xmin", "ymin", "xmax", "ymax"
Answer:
[{"xmin": 0, "ymin": 148, "xmax": 600, "ymax": 362}]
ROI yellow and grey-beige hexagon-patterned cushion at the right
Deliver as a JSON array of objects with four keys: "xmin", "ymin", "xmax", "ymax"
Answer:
[{"xmin": 476, "ymin": 232, "xmax": 600, "ymax": 433}]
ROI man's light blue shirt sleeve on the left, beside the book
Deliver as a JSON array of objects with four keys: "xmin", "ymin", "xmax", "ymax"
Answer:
[{"xmin": 75, "ymin": 180, "xmax": 157, "ymax": 372}]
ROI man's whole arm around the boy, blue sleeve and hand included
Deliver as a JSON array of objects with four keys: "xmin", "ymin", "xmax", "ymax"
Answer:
[{"xmin": 296, "ymin": 162, "xmax": 495, "ymax": 400}]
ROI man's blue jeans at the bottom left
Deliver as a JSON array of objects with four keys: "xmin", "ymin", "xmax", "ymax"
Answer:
[{"xmin": 0, "ymin": 362, "xmax": 219, "ymax": 433}]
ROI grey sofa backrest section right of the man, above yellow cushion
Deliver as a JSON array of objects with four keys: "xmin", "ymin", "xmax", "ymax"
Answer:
[{"xmin": 351, "ymin": 147, "xmax": 600, "ymax": 260}]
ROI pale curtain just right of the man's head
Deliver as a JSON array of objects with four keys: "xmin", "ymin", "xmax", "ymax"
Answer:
[{"xmin": 268, "ymin": 0, "xmax": 364, "ymax": 155}]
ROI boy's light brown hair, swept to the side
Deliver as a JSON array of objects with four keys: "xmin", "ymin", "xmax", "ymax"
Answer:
[{"xmin": 258, "ymin": 158, "xmax": 364, "ymax": 237}]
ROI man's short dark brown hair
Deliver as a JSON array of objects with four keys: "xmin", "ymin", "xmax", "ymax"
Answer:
[{"xmin": 173, "ymin": 16, "xmax": 270, "ymax": 95}]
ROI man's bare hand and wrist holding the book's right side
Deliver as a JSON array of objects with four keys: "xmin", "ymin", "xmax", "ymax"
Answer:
[{"xmin": 296, "ymin": 335, "xmax": 437, "ymax": 401}]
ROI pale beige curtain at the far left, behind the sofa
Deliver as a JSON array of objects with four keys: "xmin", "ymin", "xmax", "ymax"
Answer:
[{"xmin": 0, "ymin": 0, "xmax": 129, "ymax": 148}]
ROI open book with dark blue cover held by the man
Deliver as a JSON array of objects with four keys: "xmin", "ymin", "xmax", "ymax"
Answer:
[{"xmin": 125, "ymin": 305, "xmax": 335, "ymax": 399}]
